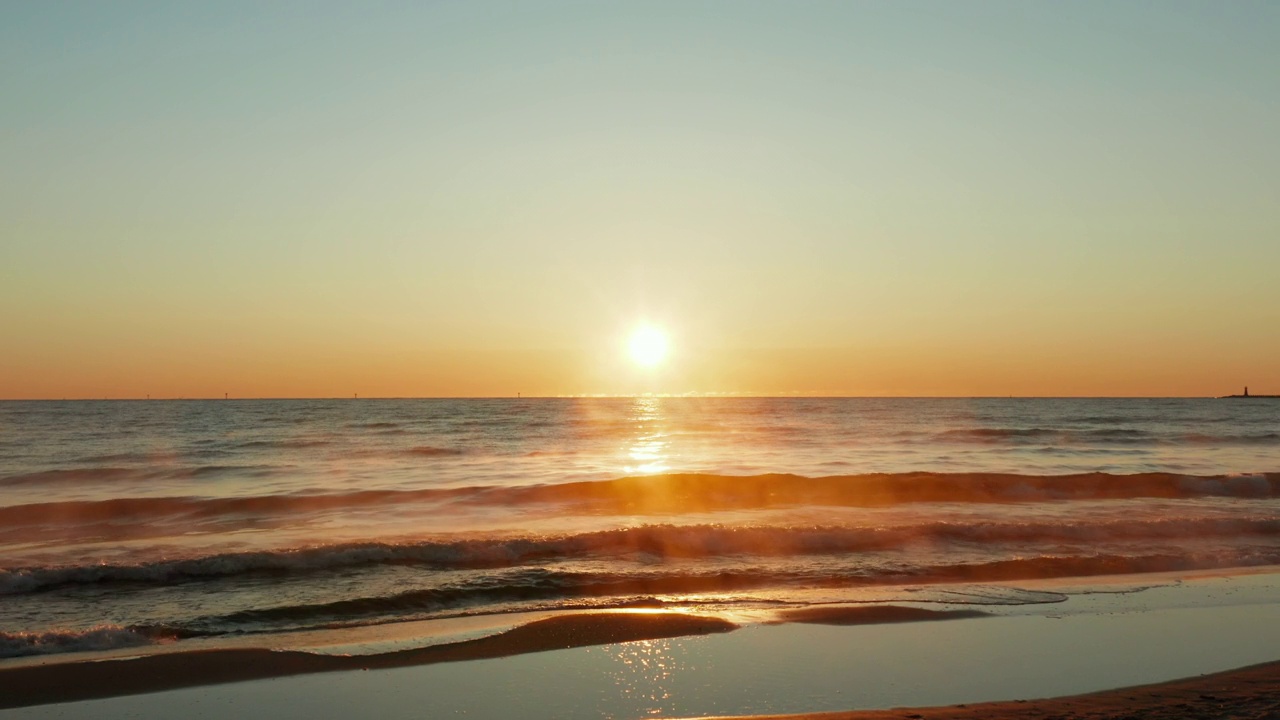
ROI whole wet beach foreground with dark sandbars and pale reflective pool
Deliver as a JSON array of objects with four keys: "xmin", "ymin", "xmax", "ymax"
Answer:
[{"xmin": 0, "ymin": 568, "xmax": 1280, "ymax": 720}]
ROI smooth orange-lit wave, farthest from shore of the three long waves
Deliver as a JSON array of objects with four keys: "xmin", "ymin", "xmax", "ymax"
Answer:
[{"xmin": 0, "ymin": 466, "xmax": 1280, "ymax": 528}]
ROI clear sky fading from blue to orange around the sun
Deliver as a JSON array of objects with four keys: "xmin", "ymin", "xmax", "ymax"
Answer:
[{"xmin": 0, "ymin": 0, "xmax": 1280, "ymax": 398}]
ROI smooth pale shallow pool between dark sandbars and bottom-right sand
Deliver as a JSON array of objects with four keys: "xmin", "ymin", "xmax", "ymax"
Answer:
[{"xmin": 4, "ymin": 575, "xmax": 1280, "ymax": 720}]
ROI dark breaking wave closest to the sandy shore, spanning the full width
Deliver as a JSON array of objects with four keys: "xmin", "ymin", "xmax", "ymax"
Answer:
[{"xmin": 0, "ymin": 548, "xmax": 1280, "ymax": 657}]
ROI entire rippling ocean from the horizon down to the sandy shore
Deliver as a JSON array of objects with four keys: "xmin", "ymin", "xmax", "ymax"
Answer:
[{"xmin": 0, "ymin": 397, "xmax": 1280, "ymax": 657}]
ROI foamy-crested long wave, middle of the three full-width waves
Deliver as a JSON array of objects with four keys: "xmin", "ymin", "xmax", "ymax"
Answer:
[{"xmin": 0, "ymin": 518, "xmax": 1280, "ymax": 594}]
